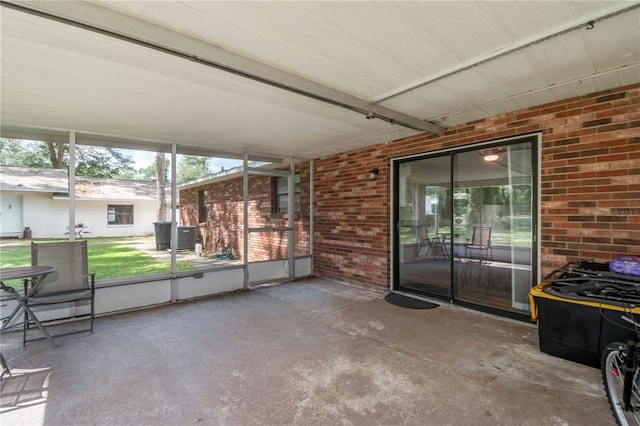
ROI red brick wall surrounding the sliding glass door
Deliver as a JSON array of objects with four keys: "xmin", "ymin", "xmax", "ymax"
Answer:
[{"xmin": 314, "ymin": 85, "xmax": 640, "ymax": 288}]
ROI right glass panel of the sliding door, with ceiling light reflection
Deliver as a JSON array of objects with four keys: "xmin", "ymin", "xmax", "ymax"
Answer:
[{"xmin": 453, "ymin": 142, "xmax": 534, "ymax": 312}]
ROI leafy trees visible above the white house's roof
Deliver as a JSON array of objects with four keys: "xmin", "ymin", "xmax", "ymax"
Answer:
[{"xmin": 0, "ymin": 138, "xmax": 133, "ymax": 178}]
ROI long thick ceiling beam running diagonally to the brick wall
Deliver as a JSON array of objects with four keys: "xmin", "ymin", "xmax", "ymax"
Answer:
[{"xmin": 0, "ymin": 0, "xmax": 444, "ymax": 135}]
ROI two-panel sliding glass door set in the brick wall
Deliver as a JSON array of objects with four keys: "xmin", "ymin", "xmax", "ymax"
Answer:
[{"xmin": 393, "ymin": 136, "xmax": 538, "ymax": 314}]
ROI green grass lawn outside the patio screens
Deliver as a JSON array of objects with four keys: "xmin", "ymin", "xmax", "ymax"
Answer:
[{"xmin": 0, "ymin": 238, "xmax": 195, "ymax": 280}]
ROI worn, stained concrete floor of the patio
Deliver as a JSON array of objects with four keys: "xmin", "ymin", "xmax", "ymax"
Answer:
[{"xmin": 0, "ymin": 279, "xmax": 614, "ymax": 426}]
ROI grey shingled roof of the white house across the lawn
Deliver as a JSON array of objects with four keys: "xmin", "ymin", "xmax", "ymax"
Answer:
[{"xmin": 0, "ymin": 166, "xmax": 156, "ymax": 201}]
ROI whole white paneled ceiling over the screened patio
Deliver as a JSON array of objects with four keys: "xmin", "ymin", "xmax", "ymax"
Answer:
[{"xmin": 0, "ymin": 0, "xmax": 640, "ymax": 158}]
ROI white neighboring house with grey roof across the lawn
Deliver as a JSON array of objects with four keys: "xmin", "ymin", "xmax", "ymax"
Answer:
[{"xmin": 0, "ymin": 166, "xmax": 165, "ymax": 238}]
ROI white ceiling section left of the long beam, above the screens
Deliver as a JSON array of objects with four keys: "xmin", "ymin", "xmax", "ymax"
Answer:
[{"xmin": 2, "ymin": 5, "xmax": 416, "ymax": 158}]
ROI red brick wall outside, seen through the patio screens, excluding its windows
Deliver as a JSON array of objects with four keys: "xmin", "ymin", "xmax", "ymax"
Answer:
[{"xmin": 180, "ymin": 163, "xmax": 310, "ymax": 261}]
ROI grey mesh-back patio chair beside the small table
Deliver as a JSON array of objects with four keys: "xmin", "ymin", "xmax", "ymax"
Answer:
[{"xmin": 23, "ymin": 240, "xmax": 95, "ymax": 344}]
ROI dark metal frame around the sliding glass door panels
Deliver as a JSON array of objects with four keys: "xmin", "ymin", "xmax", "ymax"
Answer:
[{"xmin": 389, "ymin": 132, "xmax": 542, "ymax": 320}]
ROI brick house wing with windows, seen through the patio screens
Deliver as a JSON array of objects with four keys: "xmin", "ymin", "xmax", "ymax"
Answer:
[{"xmin": 178, "ymin": 162, "xmax": 310, "ymax": 262}]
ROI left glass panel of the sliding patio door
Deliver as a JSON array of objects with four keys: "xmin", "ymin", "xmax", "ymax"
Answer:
[{"xmin": 397, "ymin": 155, "xmax": 451, "ymax": 297}]
